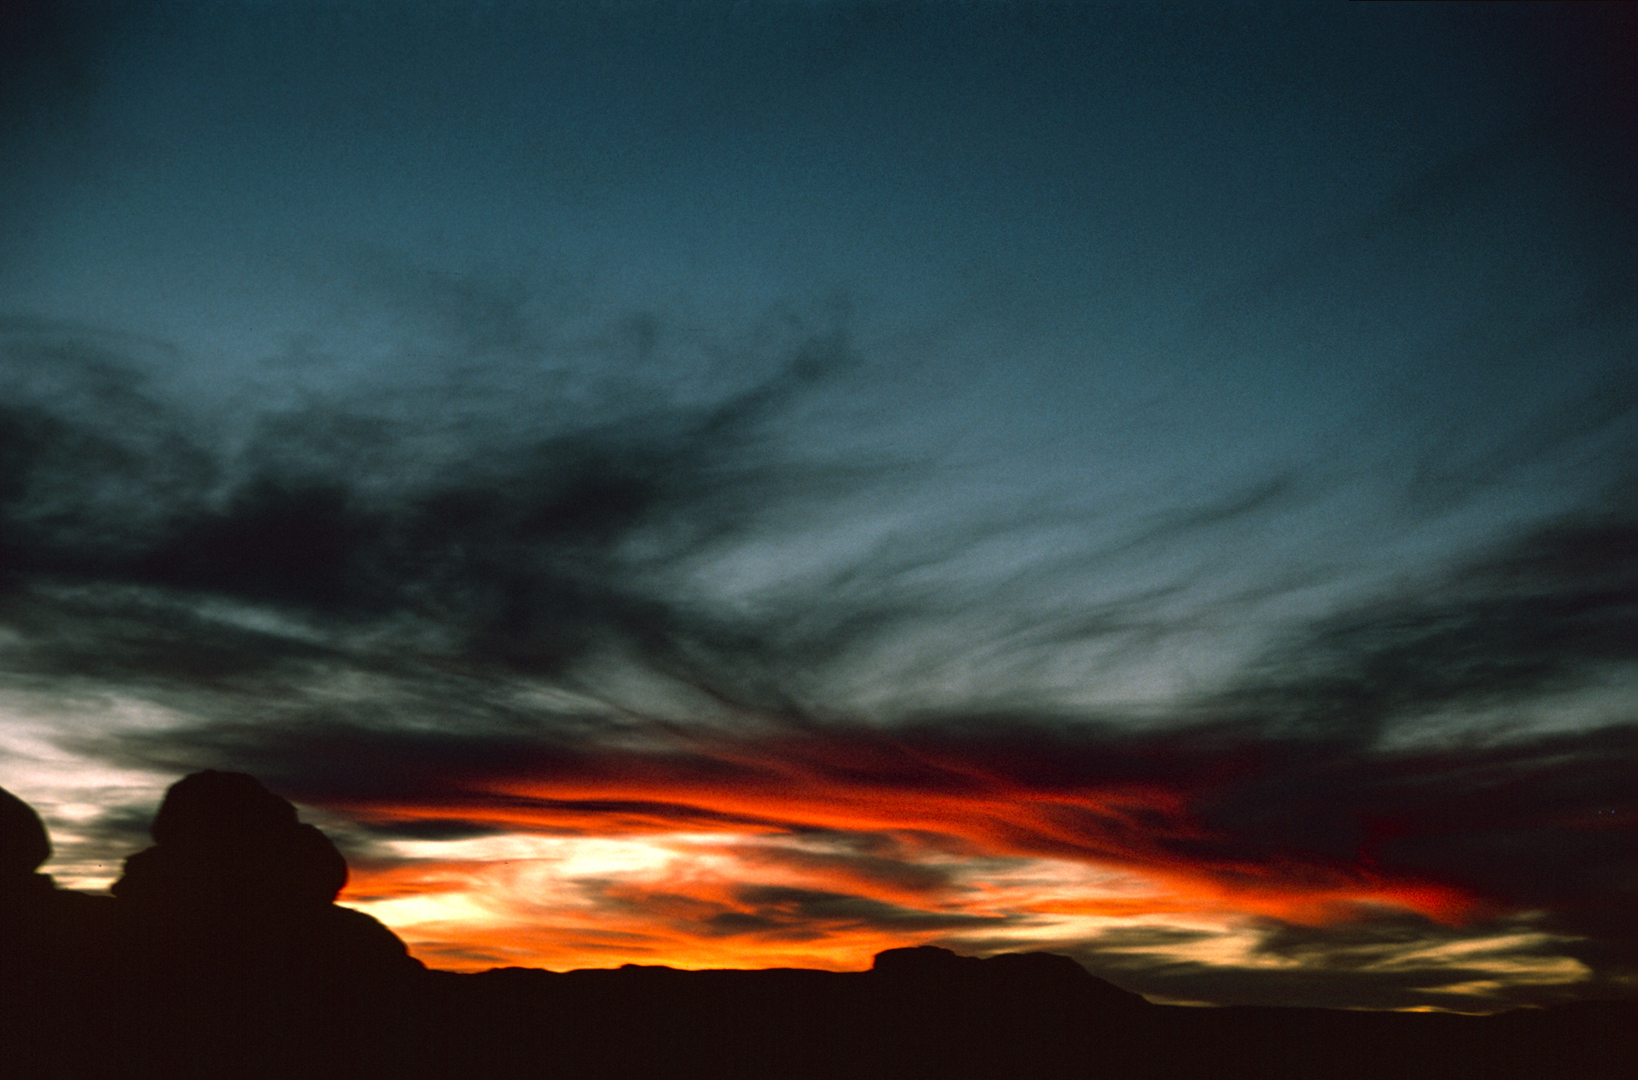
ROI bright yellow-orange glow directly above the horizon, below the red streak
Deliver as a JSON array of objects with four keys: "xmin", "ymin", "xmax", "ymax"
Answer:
[{"xmin": 346, "ymin": 834, "xmax": 1273, "ymax": 970}]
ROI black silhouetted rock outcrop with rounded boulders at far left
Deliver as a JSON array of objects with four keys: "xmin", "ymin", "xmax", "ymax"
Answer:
[{"xmin": 0, "ymin": 772, "xmax": 424, "ymax": 1080}]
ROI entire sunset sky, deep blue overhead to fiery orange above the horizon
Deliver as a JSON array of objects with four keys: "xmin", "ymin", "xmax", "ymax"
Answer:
[{"xmin": 0, "ymin": 0, "xmax": 1638, "ymax": 1011}]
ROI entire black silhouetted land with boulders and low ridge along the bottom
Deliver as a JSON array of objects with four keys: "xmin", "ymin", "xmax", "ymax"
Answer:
[{"xmin": 0, "ymin": 774, "xmax": 1638, "ymax": 1080}]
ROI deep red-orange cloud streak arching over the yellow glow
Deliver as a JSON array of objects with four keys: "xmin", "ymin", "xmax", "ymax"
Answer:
[{"xmin": 336, "ymin": 731, "xmax": 1486, "ymax": 944}]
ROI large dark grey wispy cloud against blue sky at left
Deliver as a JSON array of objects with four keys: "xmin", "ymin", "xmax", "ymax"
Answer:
[{"xmin": 0, "ymin": 308, "xmax": 884, "ymax": 698}]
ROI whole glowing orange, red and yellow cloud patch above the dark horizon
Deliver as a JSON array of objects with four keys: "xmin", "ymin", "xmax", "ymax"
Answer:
[{"xmin": 333, "ymin": 733, "xmax": 1513, "ymax": 969}]
